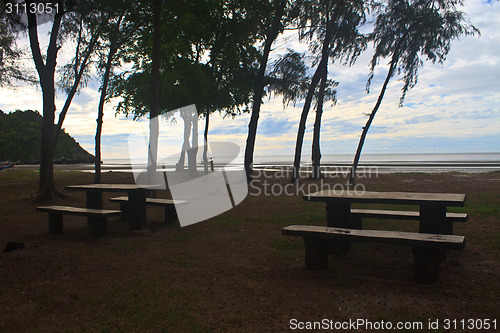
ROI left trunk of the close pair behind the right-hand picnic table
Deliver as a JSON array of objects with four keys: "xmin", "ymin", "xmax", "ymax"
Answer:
[{"xmin": 291, "ymin": 21, "xmax": 334, "ymax": 182}]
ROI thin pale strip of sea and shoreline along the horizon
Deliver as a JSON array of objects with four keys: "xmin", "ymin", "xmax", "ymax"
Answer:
[{"xmin": 88, "ymin": 153, "xmax": 500, "ymax": 173}]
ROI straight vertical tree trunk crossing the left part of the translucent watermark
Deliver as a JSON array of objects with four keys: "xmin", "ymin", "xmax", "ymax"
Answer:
[{"xmin": 147, "ymin": 0, "xmax": 161, "ymax": 184}]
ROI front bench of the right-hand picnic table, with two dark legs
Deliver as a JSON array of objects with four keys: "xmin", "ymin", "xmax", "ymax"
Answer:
[{"xmin": 282, "ymin": 225, "xmax": 465, "ymax": 283}]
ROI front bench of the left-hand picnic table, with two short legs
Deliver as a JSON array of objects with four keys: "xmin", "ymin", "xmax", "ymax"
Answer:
[{"xmin": 36, "ymin": 206, "xmax": 122, "ymax": 238}]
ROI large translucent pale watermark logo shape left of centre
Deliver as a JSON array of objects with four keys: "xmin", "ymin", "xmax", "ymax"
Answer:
[{"xmin": 128, "ymin": 105, "xmax": 248, "ymax": 227}]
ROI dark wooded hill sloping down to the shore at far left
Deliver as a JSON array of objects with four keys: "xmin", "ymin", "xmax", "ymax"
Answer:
[{"xmin": 0, "ymin": 110, "xmax": 94, "ymax": 164}]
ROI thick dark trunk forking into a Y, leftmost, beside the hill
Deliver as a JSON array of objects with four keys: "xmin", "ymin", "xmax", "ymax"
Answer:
[{"xmin": 26, "ymin": 0, "xmax": 63, "ymax": 202}]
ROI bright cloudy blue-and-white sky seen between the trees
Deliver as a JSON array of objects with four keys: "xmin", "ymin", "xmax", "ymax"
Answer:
[{"xmin": 0, "ymin": 0, "xmax": 500, "ymax": 161}]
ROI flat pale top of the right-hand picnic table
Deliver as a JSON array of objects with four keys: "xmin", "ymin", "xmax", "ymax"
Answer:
[{"xmin": 304, "ymin": 190, "xmax": 465, "ymax": 207}]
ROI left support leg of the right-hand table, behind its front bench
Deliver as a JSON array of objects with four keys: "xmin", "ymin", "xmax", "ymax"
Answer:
[{"xmin": 326, "ymin": 202, "xmax": 353, "ymax": 254}]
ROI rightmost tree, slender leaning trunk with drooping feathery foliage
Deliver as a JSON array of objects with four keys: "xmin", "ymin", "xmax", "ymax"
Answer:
[{"xmin": 349, "ymin": 0, "xmax": 479, "ymax": 185}]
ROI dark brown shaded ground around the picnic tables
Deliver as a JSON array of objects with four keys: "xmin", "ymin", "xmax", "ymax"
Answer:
[{"xmin": 0, "ymin": 169, "xmax": 500, "ymax": 332}]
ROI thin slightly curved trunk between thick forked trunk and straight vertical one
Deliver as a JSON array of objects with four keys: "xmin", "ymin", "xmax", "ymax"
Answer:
[{"xmin": 94, "ymin": 40, "xmax": 117, "ymax": 184}]
